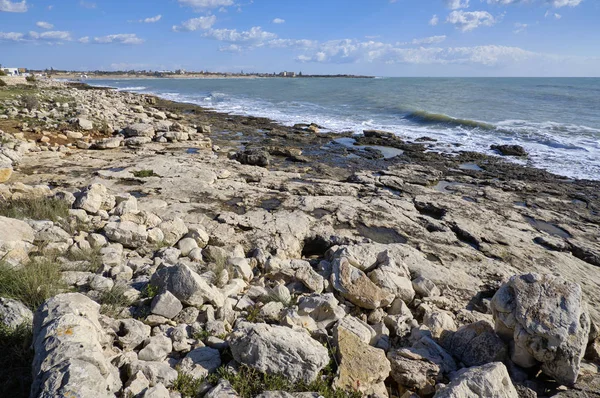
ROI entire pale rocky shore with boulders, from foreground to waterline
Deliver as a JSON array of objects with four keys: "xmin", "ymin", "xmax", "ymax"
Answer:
[{"xmin": 0, "ymin": 78, "xmax": 600, "ymax": 398}]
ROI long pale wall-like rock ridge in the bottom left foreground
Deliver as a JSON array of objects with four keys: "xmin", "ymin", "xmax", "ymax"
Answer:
[{"xmin": 31, "ymin": 293, "xmax": 121, "ymax": 398}]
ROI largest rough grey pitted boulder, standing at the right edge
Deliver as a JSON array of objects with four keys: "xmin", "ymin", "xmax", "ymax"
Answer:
[{"xmin": 491, "ymin": 274, "xmax": 590, "ymax": 384}]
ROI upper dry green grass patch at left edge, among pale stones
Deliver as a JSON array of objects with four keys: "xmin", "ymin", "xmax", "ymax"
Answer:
[{"xmin": 0, "ymin": 197, "xmax": 69, "ymax": 222}]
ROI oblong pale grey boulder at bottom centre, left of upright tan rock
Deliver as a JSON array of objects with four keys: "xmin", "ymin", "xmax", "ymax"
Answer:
[{"xmin": 229, "ymin": 323, "xmax": 329, "ymax": 383}]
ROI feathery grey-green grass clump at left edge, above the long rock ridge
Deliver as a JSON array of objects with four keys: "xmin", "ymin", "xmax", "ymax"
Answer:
[{"xmin": 0, "ymin": 257, "xmax": 66, "ymax": 311}]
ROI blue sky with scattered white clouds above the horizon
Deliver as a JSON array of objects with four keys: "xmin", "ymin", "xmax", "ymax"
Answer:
[{"xmin": 0, "ymin": 0, "xmax": 600, "ymax": 76}]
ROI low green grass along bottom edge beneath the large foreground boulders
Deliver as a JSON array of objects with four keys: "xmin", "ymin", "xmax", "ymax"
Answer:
[{"xmin": 206, "ymin": 366, "xmax": 362, "ymax": 398}]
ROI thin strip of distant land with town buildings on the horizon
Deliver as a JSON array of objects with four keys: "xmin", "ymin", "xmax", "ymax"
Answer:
[{"xmin": 0, "ymin": 65, "xmax": 373, "ymax": 79}]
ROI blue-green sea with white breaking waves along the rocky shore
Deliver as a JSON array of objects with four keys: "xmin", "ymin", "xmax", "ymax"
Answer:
[{"xmin": 89, "ymin": 78, "xmax": 600, "ymax": 180}]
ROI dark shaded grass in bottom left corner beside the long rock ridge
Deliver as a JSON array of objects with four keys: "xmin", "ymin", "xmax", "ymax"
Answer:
[{"xmin": 0, "ymin": 324, "xmax": 33, "ymax": 398}]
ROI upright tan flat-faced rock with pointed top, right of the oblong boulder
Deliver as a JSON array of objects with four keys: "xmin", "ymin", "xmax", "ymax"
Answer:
[{"xmin": 334, "ymin": 328, "xmax": 391, "ymax": 397}]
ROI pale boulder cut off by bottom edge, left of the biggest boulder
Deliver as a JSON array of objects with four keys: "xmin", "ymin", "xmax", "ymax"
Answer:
[{"xmin": 434, "ymin": 362, "xmax": 519, "ymax": 398}]
